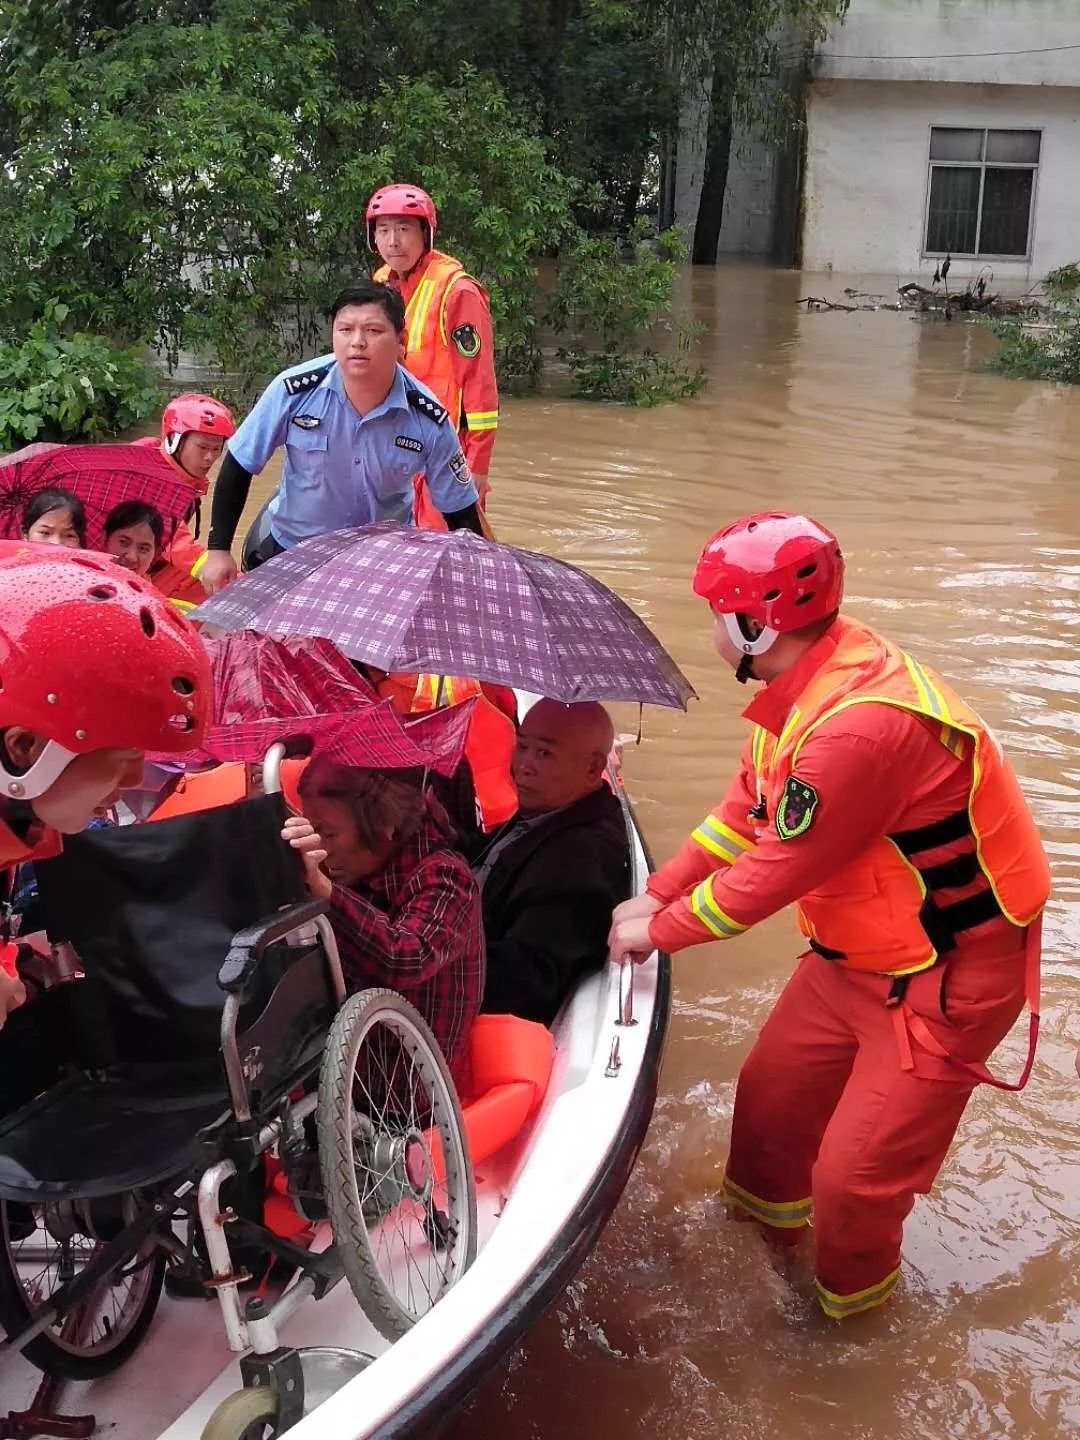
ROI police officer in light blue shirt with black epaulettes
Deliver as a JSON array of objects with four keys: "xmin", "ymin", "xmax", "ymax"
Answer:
[{"xmin": 199, "ymin": 281, "xmax": 481, "ymax": 592}]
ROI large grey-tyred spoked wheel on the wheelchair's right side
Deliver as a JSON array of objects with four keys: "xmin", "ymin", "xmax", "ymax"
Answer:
[{"xmin": 318, "ymin": 989, "xmax": 477, "ymax": 1339}]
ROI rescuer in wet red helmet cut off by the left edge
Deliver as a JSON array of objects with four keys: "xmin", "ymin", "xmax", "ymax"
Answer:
[{"xmin": 0, "ymin": 541, "xmax": 210, "ymax": 1025}]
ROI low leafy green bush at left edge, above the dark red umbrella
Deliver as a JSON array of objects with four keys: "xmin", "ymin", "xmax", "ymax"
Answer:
[{"xmin": 0, "ymin": 305, "xmax": 161, "ymax": 451}]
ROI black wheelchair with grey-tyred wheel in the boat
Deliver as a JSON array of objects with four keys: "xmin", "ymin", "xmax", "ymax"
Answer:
[{"xmin": 0, "ymin": 746, "xmax": 477, "ymax": 1436}]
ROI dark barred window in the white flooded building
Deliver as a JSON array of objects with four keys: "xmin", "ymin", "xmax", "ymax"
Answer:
[{"xmin": 924, "ymin": 125, "xmax": 1043, "ymax": 258}]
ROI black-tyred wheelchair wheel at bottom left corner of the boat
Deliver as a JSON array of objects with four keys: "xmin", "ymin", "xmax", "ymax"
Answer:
[{"xmin": 0, "ymin": 1201, "xmax": 166, "ymax": 1380}]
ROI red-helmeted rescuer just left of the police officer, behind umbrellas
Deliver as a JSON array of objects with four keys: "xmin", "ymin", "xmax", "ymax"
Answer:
[{"xmin": 135, "ymin": 393, "xmax": 236, "ymax": 611}]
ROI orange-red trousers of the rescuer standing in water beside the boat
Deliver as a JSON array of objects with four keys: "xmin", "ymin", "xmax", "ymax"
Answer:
[{"xmin": 724, "ymin": 930, "xmax": 1037, "ymax": 1319}]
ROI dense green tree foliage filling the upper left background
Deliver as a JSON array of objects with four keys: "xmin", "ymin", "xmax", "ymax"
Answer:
[{"xmin": 0, "ymin": 0, "xmax": 831, "ymax": 417}]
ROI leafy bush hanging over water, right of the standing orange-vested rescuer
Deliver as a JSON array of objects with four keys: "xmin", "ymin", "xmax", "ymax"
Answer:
[{"xmin": 549, "ymin": 220, "xmax": 706, "ymax": 405}]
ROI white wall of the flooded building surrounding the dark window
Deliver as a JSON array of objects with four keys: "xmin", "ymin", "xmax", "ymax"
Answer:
[{"xmin": 802, "ymin": 79, "xmax": 1080, "ymax": 284}]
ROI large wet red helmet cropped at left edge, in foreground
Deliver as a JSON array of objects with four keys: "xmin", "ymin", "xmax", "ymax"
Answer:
[{"xmin": 0, "ymin": 544, "xmax": 210, "ymax": 799}]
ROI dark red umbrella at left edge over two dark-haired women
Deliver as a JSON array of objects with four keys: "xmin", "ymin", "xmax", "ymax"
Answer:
[{"xmin": 0, "ymin": 445, "xmax": 199, "ymax": 550}]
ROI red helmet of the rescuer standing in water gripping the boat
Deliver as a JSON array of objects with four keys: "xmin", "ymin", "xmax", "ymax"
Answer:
[{"xmin": 694, "ymin": 511, "xmax": 844, "ymax": 655}]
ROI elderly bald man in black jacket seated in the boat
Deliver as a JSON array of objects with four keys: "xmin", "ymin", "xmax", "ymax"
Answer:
[{"xmin": 474, "ymin": 700, "xmax": 629, "ymax": 1025}]
